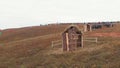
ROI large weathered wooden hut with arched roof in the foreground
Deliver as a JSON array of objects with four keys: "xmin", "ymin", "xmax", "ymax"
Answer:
[{"xmin": 62, "ymin": 25, "xmax": 83, "ymax": 51}]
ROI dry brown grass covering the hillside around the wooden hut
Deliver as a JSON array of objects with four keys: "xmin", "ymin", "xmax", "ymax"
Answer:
[{"xmin": 0, "ymin": 24, "xmax": 120, "ymax": 68}]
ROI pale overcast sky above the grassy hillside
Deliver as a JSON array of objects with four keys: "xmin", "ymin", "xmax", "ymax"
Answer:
[{"xmin": 0, "ymin": 0, "xmax": 120, "ymax": 29}]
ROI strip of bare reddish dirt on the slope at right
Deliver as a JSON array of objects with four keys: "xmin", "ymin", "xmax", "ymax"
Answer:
[{"xmin": 91, "ymin": 32, "xmax": 120, "ymax": 37}]
